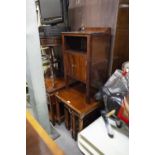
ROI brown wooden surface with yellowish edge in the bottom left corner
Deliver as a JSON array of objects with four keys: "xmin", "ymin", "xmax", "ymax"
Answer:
[{"xmin": 26, "ymin": 112, "xmax": 64, "ymax": 155}]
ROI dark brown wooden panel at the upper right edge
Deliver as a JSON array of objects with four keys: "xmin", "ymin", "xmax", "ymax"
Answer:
[{"xmin": 112, "ymin": 0, "xmax": 129, "ymax": 72}]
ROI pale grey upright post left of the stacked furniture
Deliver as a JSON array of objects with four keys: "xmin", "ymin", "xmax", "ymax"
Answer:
[{"xmin": 26, "ymin": 0, "xmax": 51, "ymax": 134}]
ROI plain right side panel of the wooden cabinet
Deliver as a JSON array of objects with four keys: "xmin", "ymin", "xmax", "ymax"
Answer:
[{"xmin": 91, "ymin": 35, "xmax": 111, "ymax": 88}]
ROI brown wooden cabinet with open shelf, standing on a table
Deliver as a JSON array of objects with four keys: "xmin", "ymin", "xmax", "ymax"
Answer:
[{"xmin": 62, "ymin": 28, "xmax": 111, "ymax": 100}]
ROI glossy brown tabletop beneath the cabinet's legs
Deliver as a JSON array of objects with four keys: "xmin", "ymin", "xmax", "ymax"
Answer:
[{"xmin": 55, "ymin": 84, "xmax": 99, "ymax": 117}]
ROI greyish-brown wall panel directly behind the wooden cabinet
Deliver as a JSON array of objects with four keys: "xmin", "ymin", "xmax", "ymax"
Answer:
[{"xmin": 69, "ymin": 0, "xmax": 119, "ymax": 75}]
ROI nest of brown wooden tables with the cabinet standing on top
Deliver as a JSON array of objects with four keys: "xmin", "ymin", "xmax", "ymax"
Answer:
[{"xmin": 55, "ymin": 84, "xmax": 101, "ymax": 140}]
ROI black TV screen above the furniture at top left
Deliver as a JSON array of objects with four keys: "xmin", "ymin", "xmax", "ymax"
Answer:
[{"xmin": 39, "ymin": 0, "xmax": 63, "ymax": 24}]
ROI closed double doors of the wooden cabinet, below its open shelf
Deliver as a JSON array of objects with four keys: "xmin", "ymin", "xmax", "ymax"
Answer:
[{"xmin": 64, "ymin": 52, "xmax": 87, "ymax": 82}]
